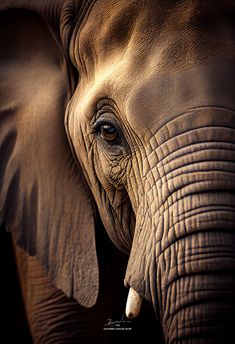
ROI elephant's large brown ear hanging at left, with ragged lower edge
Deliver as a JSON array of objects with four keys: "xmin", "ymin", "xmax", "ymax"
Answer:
[{"xmin": 0, "ymin": 10, "xmax": 99, "ymax": 307}]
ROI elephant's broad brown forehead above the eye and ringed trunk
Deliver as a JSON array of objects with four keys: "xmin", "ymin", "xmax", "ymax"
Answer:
[{"xmin": 77, "ymin": 0, "xmax": 235, "ymax": 132}]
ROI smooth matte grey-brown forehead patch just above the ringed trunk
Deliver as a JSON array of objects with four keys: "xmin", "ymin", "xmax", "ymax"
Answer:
[{"xmin": 125, "ymin": 58, "xmax": 235, "ymax": 138}]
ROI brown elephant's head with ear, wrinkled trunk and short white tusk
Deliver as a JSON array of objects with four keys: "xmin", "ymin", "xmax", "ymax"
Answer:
[{"xmin": 0, "ymin": 0, "xmax": 235, "ymax": 344}]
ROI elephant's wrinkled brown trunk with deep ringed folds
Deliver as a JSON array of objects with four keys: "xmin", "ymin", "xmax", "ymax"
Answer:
[{"xmin": 125, "ymin": 107, "xmax": 235, "ymax": 344}]
